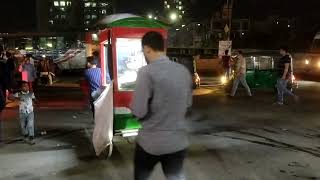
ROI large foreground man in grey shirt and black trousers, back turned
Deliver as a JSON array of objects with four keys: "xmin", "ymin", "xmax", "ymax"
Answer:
[{"xmin": 131, "ymin": 32, "xmax": 192, "ymax": 180}]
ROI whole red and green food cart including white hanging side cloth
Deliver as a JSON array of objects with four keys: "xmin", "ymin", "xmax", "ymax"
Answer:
[{"xmin": 89, "ymin": 14, "xmax": 167, "ymax": 156}]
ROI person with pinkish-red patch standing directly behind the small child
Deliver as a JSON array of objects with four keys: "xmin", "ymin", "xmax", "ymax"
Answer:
[{"xmin": 19, "ymin": 58, "xmax": 37, "ymax": 92}]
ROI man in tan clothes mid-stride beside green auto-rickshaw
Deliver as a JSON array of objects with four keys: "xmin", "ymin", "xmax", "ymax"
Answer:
[{"xmin": 230, "ymin": 50, "xmax": 252, "ymax": 97}]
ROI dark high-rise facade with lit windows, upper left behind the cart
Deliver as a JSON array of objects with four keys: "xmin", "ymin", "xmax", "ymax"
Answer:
[{"xmin": 37, "ymin": 0, "xmax": 113, "ymax": 32}]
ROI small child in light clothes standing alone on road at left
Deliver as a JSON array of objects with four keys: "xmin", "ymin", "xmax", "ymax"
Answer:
[{"xmin": 13, "ymin": 82, "xmax": 35, "ymax": 145}]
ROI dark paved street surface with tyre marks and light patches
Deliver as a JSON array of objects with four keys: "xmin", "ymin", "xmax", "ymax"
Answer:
[{"xmin": 0, "ymin": 82, "xmax": 320, "ymax": 180}]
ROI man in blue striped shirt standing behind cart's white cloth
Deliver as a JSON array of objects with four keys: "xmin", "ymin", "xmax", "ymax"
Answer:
[{"xmin": 84, "ymin": 57, "xmax": 110, "ymax": 117}]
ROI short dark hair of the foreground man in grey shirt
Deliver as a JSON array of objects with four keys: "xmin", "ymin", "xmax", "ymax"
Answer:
[{"xmin": 142, "ymin": 31, "xmax": 164, "ymax": 51}]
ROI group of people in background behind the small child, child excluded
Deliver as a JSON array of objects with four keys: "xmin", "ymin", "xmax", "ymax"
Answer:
[{"xmin": 0, "ymin": 51, "xmax": 55, "ymax": 97}]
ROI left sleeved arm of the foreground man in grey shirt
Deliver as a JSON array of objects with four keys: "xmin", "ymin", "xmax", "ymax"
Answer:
[{"xmin": 131, "ymin": 69, "xmax": 152, "ymax": 120}]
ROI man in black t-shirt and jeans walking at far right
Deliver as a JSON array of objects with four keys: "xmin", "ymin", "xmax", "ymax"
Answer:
[{"xmin": 275, "ymin": 46, "xmax": 299, "ymax": 105}]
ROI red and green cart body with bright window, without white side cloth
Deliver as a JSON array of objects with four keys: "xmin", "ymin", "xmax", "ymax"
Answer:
[{"xmin": 89, "ymin": 14, "xmax": 167, "ymax": 156}]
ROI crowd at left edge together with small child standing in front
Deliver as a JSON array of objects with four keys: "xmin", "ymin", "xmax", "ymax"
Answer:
[{"xmin": 0, "ymin": 51, "xmax": 55, "ymax": 145}]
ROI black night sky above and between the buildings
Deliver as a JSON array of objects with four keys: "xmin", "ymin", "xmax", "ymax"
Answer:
[{"xmin": 0, "ymin": 0, "xmax": 320, "ymax": 32}]
